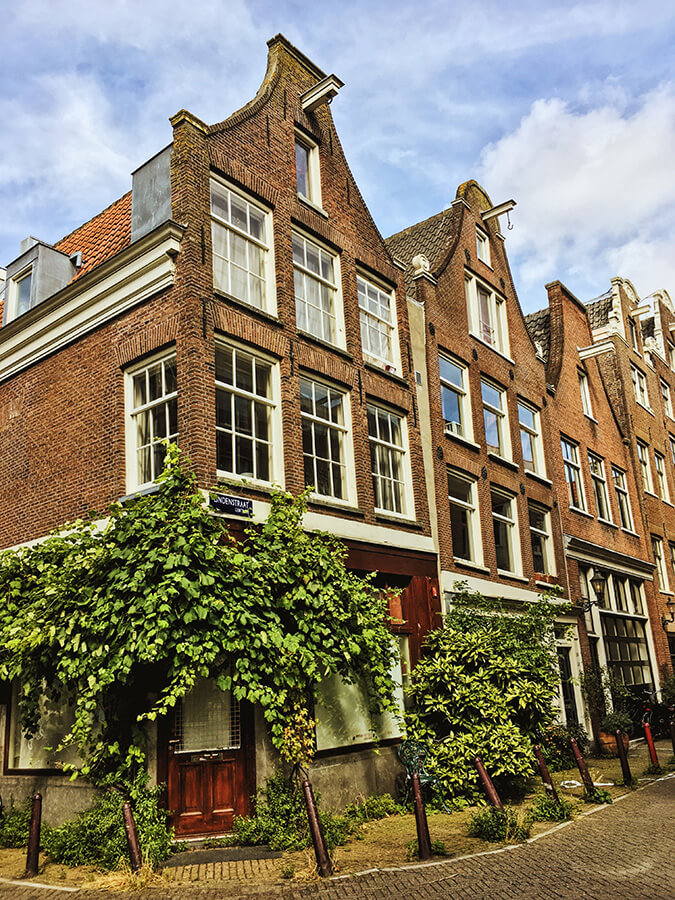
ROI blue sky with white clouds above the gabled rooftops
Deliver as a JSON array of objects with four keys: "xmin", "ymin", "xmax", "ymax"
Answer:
[{"xmin": 0, "ymin": 0, "xmax": 675, "ymax": 311}]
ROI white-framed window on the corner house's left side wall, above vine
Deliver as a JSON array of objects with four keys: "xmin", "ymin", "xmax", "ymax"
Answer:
[{"xmin": 127, "ymin": 353, "xmax": 178, "ymax": 489}]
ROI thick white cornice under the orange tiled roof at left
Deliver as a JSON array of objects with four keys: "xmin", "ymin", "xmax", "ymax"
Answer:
[{"xmin": 0, "ymin": 222, "xmax": 184, "ymax": 381}]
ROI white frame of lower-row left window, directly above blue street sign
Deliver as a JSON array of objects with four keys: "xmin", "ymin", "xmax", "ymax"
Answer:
[{"xmin": 214, "ymin": 337, "xmax": 284, "ymax": 487}]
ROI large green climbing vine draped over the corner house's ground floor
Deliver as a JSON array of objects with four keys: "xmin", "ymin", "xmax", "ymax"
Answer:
[{"xmin": 0, "ymin": 445, "xmax": 396, "ymax": 784}]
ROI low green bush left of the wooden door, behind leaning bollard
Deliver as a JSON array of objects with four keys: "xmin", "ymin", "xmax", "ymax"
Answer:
[{"xmin": 42, "ymin": 776, "xmax": 173, "ymax": 869}]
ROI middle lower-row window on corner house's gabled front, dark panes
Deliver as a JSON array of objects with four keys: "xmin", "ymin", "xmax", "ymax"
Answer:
[{"xmin": 300, "ymin": 378, "xmax": 348, "ymax": 500}]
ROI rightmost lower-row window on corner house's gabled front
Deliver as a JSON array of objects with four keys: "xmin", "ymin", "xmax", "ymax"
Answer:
[{"xmin": 367, "ymin": 403, "xmax": 407, "ymax": 514}]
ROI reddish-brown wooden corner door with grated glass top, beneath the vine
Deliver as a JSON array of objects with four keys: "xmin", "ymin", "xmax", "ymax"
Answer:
[{"xmin": 168, "ymin": 679, "xmax": 251, "ymax": 836}]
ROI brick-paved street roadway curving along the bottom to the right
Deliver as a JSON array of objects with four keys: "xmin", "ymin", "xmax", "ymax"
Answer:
[{"xmin": 0, "ymin": 777, "xmax": 675, "ymax": 900}]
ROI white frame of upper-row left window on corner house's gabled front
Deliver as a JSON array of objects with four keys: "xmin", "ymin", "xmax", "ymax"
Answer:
[{"xmin": 210, "ymin": 174, "xmax": 277, "ymax": 316}]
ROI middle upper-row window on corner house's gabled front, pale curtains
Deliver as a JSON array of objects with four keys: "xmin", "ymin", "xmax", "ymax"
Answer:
[{"xmin": 293, "ymin": 234, "xmax": 341, "ymax": 344}]
